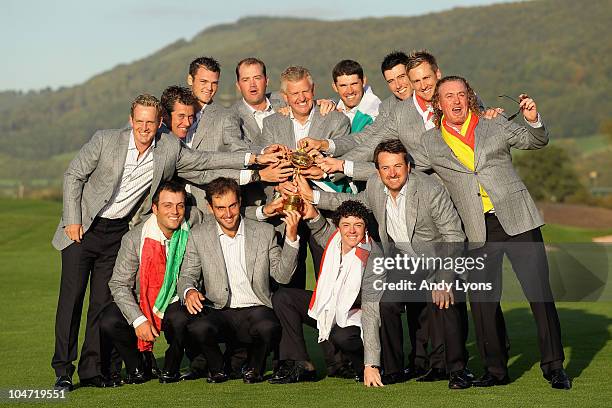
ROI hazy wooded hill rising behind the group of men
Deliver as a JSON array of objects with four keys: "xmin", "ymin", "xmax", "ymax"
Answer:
[{"xmin": 0, "ymin": 0, "xmax": 612, "ymax": 163}]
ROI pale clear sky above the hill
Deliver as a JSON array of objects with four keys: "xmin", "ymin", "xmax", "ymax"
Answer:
[{"xmin": 0, "ymin": 0, "xmax": 507, "ymax": 90}]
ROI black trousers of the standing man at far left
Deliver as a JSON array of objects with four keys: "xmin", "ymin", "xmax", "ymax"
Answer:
[{"xmin": 51, "ymin": 218, "xmax": 128, "ymax": 379}]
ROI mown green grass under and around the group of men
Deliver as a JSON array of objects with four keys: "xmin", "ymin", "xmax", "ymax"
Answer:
[{"xmin": 0, "ymin": 200, "xmax": 612, "ymax": 408}]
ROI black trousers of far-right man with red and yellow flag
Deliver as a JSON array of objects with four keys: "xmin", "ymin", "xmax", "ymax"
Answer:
[{"xmin": 469, "ymin": 214, "xmax": 565, "ymax": 378}]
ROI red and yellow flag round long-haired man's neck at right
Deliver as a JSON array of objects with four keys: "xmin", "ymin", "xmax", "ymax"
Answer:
[{"xmin": 440, "ymin": 111, "xmax": 493, "ymax": 213}]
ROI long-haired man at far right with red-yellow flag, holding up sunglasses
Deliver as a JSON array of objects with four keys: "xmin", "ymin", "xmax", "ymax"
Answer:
[{"xmin": 415, "ymin": 76, "xmax": 571, "ymax": 389}]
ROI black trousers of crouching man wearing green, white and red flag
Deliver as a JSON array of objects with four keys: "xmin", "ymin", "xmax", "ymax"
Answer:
[{"xmin": 100, "ymin": 302, "xmax": 189, "ymax": 373}]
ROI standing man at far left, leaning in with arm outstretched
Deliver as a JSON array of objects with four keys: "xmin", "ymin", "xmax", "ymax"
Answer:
[{"xmin": 51, "ymin": 94, "xmax": 277, "ymax": 390}]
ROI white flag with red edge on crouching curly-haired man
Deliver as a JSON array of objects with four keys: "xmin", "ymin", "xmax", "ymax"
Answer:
[{"xmin": 308, "ymin": 230, "xmax": 372, "ymax": 343}]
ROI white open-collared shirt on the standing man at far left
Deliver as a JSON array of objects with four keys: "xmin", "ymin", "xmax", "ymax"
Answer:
[{"xmin": 99, "ymin": 131, "xmax": 155, "ymax": 219}]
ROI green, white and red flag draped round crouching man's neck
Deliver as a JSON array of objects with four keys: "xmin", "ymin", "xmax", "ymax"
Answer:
[{"xmin": 138, "ymin": 214, "xmax": 189, "ymax": 351}]
